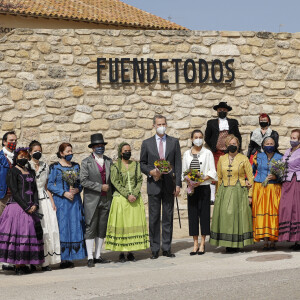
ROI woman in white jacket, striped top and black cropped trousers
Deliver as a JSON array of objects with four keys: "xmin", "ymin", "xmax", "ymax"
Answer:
[{"xmin": 182, "ymin": 129, "xmax": 217, "ymax": 255}]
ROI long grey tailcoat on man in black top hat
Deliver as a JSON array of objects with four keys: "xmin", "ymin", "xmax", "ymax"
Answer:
[{"xmin": 80, "ymin": 154, "xmax": 113, "ymax": 225}]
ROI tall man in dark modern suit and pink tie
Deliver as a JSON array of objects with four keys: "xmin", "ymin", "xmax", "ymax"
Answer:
[{"xmin": 140, "ymin": 115, "xmax": 182, "ymax": 259}]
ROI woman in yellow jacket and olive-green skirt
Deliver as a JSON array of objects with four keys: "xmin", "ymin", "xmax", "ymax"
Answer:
[{"xmin": 209, "ymin": 134, "xmax": 254, "ymax": 253}]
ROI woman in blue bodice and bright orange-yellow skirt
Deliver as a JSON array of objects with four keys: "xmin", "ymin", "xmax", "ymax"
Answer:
[{"xmin": 252, "ymin": 136, "xmax": 282, "ymax": 250}]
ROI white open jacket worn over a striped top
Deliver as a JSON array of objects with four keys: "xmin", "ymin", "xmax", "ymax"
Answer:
[{"xmin": 182, "ymin": 147, "xmax": 218, "ymax": 185}]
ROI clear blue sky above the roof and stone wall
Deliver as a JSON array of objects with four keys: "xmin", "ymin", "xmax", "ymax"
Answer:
[{"xmin": 122, "ymin": 0, "xmax": 300, "ymax": 32}]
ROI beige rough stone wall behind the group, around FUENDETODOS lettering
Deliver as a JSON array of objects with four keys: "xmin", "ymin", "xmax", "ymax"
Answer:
[{"xmin": 0, "ymin": 29, "xmax": 300, "ymax": 169}]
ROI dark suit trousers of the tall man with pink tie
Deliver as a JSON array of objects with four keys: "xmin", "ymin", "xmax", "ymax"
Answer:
[{"xmin": 148, "ymin": 192, "xmax": 174, "ymax": 252}]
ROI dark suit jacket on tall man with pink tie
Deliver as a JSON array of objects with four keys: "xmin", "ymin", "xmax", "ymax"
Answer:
[{"xmin": 140, "ymin": 135, "xmax": 182, "ymax": 195}]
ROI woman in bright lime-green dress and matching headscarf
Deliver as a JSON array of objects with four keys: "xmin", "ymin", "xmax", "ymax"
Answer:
[{"xmin": 105, "ymin": 142, "xmax": 149, "ymax": 262}]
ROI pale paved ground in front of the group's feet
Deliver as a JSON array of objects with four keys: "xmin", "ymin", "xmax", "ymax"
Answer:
[{"xmin": 0, "ymin": 238, "xmax": 300, "ymax": 300}]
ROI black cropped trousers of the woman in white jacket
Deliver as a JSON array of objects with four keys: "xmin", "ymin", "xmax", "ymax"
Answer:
[{"xmin": 188, "ymin": 185, "xmax": 210, "ymax": 236}]
